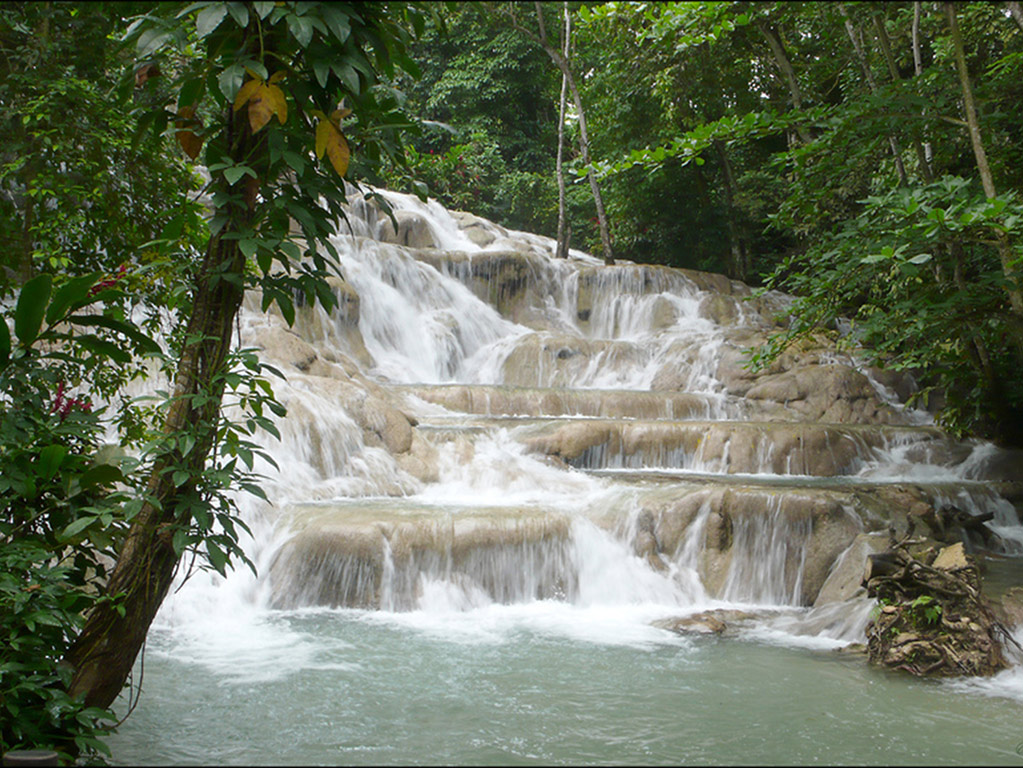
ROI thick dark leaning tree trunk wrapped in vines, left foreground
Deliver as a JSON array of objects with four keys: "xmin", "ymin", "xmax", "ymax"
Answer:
[{"xmin": 65, "ymin": 100, "xmax": 259, "ymax": 708}]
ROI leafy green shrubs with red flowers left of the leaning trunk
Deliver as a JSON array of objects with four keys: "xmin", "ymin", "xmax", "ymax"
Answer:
[{"xmin": 0, "ymin": 272, "xmax": 160, "ymax": 760}]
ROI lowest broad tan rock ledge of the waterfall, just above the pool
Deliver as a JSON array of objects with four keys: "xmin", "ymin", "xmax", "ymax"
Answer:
[{"xmin": 268, "ymin": 482, "xmax": 1014, "ymax": 611}]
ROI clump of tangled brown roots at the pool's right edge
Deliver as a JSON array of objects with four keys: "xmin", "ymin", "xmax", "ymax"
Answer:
[{"xmin": 864, "ymin": 543, "xmax": 1009, "ymax": 677}]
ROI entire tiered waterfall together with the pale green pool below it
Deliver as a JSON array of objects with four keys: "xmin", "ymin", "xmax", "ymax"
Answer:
[{"xmin": 110, "ymin": 192, "xmax": 1023, "ymax": 765}]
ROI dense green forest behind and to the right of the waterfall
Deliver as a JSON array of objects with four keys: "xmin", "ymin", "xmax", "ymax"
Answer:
[{"xmin": 380, "ymin": 2, "xmax": 1023, "ymax": 443}]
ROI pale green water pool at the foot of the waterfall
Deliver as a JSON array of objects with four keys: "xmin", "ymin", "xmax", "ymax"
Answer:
[{"xmin": 110, "ymin": 602, "xmax": 1023, "ymax": 765}]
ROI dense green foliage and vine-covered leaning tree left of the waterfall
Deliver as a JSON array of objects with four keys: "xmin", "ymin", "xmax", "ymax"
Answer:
[{"xmin": 0, "ymin": 2, "xmax": 424, "ymax": 760}]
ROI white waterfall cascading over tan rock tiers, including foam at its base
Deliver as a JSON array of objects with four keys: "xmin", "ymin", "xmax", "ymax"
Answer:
[{"xmin": 107, "ymin": 190, "xmax": 1023, "ymax": 762}]
